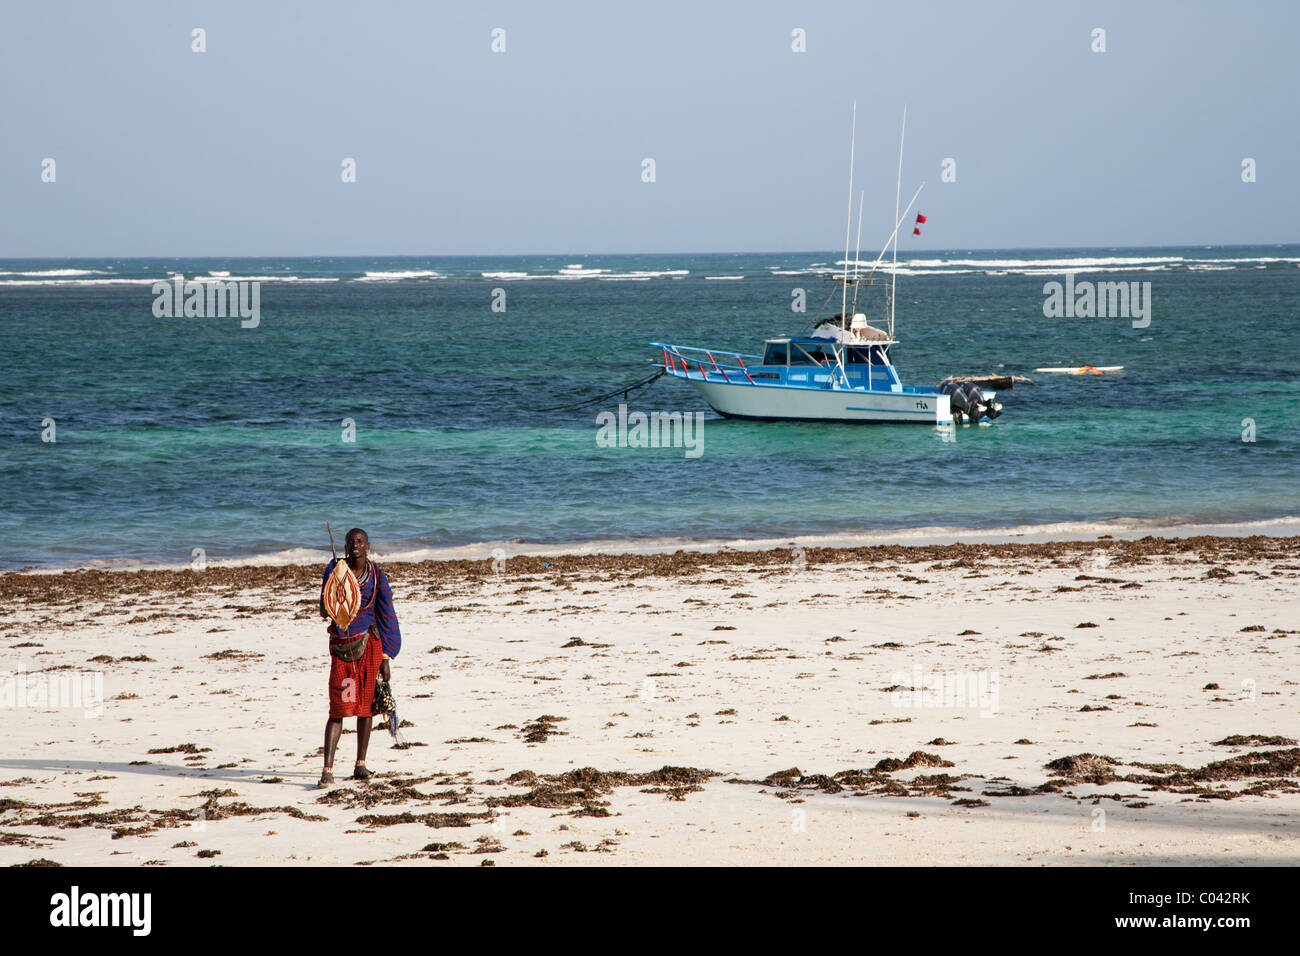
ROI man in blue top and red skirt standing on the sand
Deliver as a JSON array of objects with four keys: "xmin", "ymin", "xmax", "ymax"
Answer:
[{"xmin": 320, "ymin": 528, "xmax": 402, "ymax": 787}]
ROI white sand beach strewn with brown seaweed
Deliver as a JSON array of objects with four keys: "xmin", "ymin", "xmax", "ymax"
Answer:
[{"xmin": 0, "ymin": 537, "xmax": 1300, "ymax": 866}]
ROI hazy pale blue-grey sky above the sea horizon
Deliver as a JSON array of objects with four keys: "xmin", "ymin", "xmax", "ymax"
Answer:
[{"xmin": 0, "ymin": 0, "xmax": 1300, "ymax": 256}]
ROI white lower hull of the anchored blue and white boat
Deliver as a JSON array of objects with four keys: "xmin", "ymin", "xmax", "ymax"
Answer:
[{"xmin": 679, "ymin": 376, "xmax": 953, "ymax": 425}]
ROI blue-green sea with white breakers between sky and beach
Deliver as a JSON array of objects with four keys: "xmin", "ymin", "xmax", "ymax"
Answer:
[{"xmin": 0, "ymin": 246, "xmax": 1300, "ymax": 568}]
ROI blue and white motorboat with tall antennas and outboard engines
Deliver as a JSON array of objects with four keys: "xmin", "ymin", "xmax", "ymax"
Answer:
[{"xmin": 651, "ymin": 109, "xmax": 1002, "ymax": 425}]
